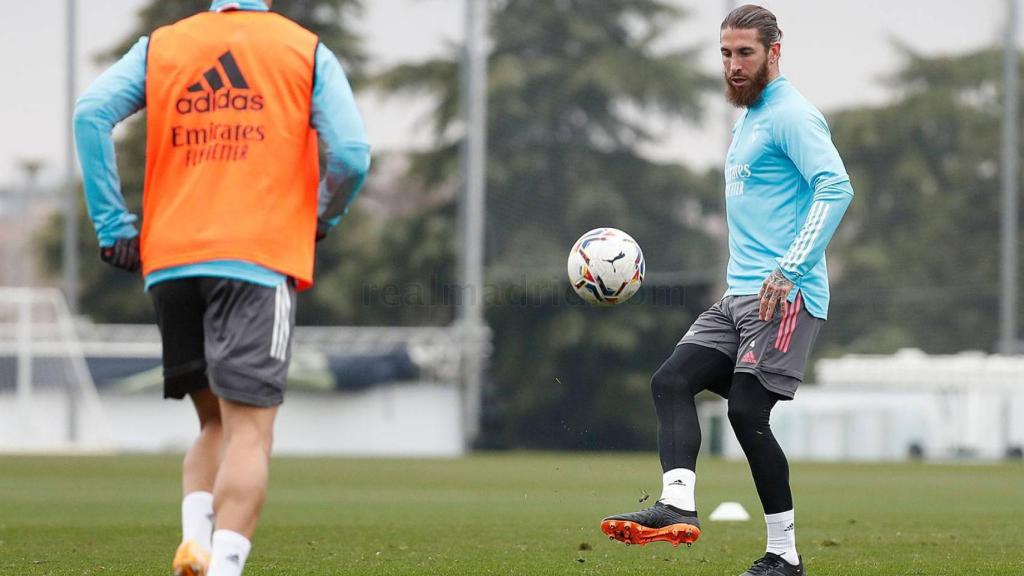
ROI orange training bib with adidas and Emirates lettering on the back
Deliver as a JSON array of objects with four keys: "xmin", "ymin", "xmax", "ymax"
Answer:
[{"xmin": 141, "ymin": 11, "xmax": 319, "ymax": 289}]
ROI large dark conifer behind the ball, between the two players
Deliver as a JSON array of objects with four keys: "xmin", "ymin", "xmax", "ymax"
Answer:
[{"xmin": 375, "ymin": 0, "xmax": 721, "ymax": 448}]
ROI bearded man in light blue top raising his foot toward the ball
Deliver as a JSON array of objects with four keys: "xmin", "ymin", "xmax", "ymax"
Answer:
[{"xmin": 601, "ymin": 5, "xmax": 853, "ymax": 576}]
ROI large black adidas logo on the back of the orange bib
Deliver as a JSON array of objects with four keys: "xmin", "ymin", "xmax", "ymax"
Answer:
[{"xmin": 174, "ymin": 50, "xmax": 263, "ymax": 115}]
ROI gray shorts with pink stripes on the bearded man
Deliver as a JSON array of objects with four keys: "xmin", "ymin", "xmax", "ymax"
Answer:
[{"xmin": 679, "ymin": 292, "xmax": 824, "ymax": 400}]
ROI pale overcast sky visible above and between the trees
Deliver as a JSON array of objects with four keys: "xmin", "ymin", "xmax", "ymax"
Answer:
[{"xmin": 0, "ymin": 0, "xmax": 1007, "ymax": 188}]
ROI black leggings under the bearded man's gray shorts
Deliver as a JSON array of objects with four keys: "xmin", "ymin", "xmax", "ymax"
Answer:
[{"xmin": 650, "ymin": 344, "xmax": 793, "ymax": 513}]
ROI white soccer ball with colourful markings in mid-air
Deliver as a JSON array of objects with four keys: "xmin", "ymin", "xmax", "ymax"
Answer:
[{"xmin": 568, "ymin": 228, "xmax": 644, "ymax": 305}]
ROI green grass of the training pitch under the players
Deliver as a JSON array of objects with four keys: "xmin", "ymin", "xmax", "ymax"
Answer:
[{"xmin": 0, "ymin": 454, "xmax": 1024, "ymax": 576}]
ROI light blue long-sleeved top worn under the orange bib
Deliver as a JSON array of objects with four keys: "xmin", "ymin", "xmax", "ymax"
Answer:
[{"xmin": 74, "ymin": 0, "xmax": 370, "ymax": 290}]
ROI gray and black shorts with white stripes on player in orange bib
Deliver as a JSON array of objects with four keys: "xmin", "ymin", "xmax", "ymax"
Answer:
[{"xmin": 150, "ymin": 277, "xmax": 295, "ymax": 407}]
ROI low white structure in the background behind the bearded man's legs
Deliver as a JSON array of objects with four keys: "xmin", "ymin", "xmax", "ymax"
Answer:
[{"xmin": 703, "ymin": 349, "xmax": 1024, "ymax": 460}]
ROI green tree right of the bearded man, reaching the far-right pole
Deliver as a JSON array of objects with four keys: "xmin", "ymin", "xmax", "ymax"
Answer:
[{"xmin": 820, "ymin": 48, "xmax": 1020, "ymax": 354}]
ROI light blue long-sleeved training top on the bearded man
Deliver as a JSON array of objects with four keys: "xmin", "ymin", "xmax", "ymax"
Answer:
[{"xmin": 725, "ymin": 76, "xmax": 853, "ymax": 319}]
